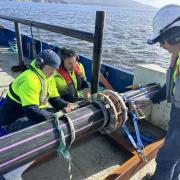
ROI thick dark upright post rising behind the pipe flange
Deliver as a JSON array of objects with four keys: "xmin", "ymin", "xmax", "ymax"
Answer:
[{"xmin": 91, "ymin": 11, "xmax": 105, "ymax": 94}]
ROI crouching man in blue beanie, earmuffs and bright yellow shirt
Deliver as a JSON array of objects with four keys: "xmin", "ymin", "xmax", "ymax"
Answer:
[{"xmin": 0, "ymin": 50, "xmax": 74, "ymax": 132}]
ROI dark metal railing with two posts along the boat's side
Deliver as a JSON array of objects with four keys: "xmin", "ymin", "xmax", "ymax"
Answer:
[{"xmin": 0, "ymin": 11, "xmax": 105, "ymax": 94}]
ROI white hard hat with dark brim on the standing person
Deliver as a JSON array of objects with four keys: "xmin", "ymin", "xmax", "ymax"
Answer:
[{"xmin": 148, "ymin": 4, "xmax": 180, "ymax": 44}]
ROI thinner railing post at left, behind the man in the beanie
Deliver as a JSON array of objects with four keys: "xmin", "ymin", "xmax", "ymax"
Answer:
[{"xmin": 14, "ymin": 22, "xmax": 24, "ymax": 66}]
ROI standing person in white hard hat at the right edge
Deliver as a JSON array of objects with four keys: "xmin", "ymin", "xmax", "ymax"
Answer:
[{"xmin": 143, "ymin": 5, "xmax": 180, "ymax": 180}]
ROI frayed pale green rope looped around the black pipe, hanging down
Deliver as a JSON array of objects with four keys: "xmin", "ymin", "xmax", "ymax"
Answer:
[{"xmin": 55, "ymin": 115, "xmax": 75, "ymax": 180}]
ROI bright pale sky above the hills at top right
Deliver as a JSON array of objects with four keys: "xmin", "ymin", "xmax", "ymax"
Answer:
[{"xmin": 135, "ymin": 0, "xmax": 180, "ymax": 8}]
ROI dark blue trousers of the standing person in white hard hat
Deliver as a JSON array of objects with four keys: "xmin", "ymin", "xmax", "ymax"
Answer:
[{"xmin": 152, "ymin": 106, "xmax": 180, "ymax": 180}]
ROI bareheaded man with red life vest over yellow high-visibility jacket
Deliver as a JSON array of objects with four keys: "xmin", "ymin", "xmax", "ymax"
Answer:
[{"xmin": 54, "ymin": 48, "xmax": 91, "ymax": 102}]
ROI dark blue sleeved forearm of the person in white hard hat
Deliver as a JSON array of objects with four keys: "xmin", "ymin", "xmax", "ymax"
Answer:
[{"xmin": 151, "ymin": 84, "xmax": 166, "ymax": 104}]
